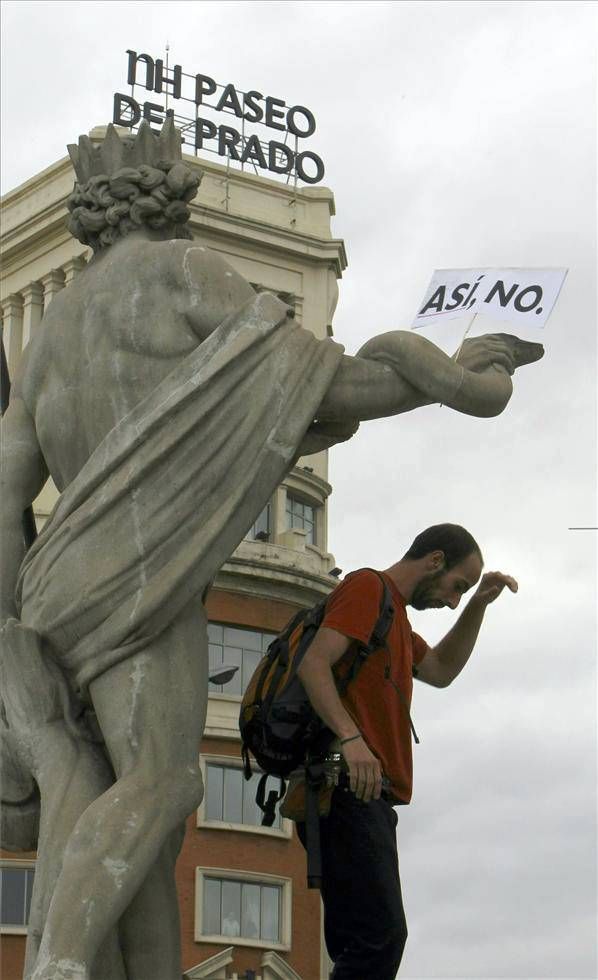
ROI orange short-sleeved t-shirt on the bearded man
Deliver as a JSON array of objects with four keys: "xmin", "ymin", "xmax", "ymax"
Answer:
[{"xmin": 321, "ymin": 569, "xmax": 428, "ymax": 803}]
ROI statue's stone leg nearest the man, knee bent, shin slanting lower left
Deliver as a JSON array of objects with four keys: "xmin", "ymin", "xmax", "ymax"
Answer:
[{"xmin": 32, "ymin": 601, "xmax": 208, "ymax": 980}]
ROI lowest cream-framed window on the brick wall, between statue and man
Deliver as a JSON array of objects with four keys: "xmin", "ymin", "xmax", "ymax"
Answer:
[{"xmin": 195, "ymin": 868, "xmax": 291, "ymax": 949}]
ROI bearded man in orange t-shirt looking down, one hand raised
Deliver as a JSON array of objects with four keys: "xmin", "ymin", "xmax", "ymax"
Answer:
[{"xmin": 296, "ymin": 524, "xmax": 517, "ymax": 980}]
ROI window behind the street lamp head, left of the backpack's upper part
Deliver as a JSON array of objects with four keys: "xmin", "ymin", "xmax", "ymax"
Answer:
[{"xmin": 208, "ymin": 623, "xmax": 276, "ymax": 696}]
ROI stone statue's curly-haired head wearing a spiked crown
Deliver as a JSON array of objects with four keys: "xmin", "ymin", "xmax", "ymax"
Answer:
[{"xmin": 67, "ymin": 116, "xmax": 201, "ymax": 252}]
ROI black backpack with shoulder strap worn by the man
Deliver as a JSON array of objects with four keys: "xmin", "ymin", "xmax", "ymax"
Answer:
[{"xmin": 239, "ymin": 569, "xmax": 394, "ymax": 827}]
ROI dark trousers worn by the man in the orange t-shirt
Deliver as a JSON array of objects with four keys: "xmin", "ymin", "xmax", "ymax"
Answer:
[{"xmin": 297, "ymin": 787, "xmax": 407, "ymax": 980}]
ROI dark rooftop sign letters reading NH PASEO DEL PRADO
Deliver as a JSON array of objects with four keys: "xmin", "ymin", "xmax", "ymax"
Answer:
[{"xmin": 112, "ymin": 50, "xmax": 324, "ymax": 184}]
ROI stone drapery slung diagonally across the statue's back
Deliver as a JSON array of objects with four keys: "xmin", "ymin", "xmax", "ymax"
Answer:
[{"xmin": 17, "ymin": 293, "xmax": 349, "ymax": 692}]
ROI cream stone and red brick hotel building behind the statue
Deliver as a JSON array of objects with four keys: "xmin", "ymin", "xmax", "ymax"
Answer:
[{"xmin": 0, "ymin": 127, "xmax": 346, "ymax": 980}]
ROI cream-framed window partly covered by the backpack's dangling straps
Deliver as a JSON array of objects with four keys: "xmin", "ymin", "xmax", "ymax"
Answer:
[{"xmin": 204, "ymin": 762, "xmax": 281, "ymax": 830}]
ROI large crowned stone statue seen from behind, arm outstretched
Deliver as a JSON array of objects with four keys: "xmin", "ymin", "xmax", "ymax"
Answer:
[{"xmin": 0, "ymin": 120, "xmax": 543, "ymax": 980}]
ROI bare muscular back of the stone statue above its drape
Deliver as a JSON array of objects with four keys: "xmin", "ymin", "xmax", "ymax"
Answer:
[{"xmin": 22, "ymin": 239, "xmax": 209, "ymax": 490}]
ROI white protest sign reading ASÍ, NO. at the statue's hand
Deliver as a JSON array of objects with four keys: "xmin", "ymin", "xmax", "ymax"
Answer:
[{"xmin": 412, "ymin": 269, "xmax": 568, "ymax": 327}]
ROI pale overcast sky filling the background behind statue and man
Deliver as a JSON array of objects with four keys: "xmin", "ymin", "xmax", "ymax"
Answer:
[{"xmin": 2, "ymin": 0, "xmax": 598, "ymax": 980}]
